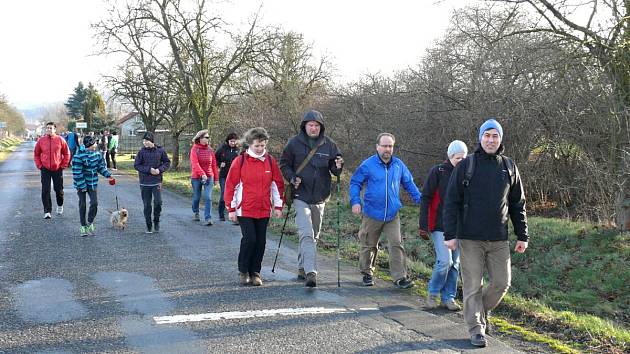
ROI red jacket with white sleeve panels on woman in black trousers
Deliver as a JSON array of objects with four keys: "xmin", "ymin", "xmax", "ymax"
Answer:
[{"xmin": 223, "ymin": 153, "xmax": 284, "ymax": 219}]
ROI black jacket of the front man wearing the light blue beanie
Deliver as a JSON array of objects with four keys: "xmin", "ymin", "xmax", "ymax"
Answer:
[{"xmin": 442, "ymin": 145, "xmax": 529, "ymax": 241}]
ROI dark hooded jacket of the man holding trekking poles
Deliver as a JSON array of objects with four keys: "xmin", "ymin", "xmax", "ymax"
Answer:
[{"xmin": 280, "ymin": 118, "xmax": 341, "ymax": 204}]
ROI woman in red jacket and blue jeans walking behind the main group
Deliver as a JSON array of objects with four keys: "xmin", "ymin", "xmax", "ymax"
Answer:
[{"xmin": 190, "ymin": 129, "xmax": 219, "ymax": 226}]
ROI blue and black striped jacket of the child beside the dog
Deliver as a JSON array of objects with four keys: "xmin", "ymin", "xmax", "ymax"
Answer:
[{"xmin": 72, "ymin": 145, "xmax": 112, "ymax": 190}]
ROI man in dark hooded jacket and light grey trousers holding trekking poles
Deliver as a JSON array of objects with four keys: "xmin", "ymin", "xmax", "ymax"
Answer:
[{"xmin": 280, "ymin": 110, "xmax": 343, "ymax": 287}]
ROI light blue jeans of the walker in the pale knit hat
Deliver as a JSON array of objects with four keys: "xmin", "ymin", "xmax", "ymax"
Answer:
[{"xmin": 429, "ymin": 231, "xmax": 459, "ymax": 303}]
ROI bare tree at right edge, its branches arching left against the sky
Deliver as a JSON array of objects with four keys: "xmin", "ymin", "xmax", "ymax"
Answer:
[{"xmin": 491, "ymin": 0, "xmax": 630, "ymax": 230}]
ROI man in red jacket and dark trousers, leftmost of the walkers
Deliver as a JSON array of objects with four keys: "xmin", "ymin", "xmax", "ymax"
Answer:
[{"xmin": 33, "ymin": 122, "xmax": 70, "ymax": 219}]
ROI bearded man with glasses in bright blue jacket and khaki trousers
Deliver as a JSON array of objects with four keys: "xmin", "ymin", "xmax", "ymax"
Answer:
[{"xmin": 350, "ymin": 133, "xmax": 422, "ymax": 289}]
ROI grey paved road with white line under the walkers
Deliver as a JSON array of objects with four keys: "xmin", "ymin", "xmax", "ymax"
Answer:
[{"xmin": 0, "ymin": 143, "xmax": 517, "ymax": 353}]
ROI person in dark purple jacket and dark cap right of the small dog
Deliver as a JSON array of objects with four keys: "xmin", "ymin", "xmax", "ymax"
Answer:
[{"xmin": 133, "ymin": 132, "xmax": 171, "ymax": 234}]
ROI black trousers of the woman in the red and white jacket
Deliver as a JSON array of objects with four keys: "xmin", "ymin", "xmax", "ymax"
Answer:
[{"xmin": 238, "ymin": 216, "xmax": 269, "ymax": 275}]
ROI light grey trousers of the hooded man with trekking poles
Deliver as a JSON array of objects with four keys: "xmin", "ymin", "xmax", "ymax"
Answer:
[{"xmin": 293, "ymin": 199, "xmax": 326, "ymax": 274}]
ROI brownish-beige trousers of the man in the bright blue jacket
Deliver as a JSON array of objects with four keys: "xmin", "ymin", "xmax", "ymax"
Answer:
[{"xmin": 359, "ymin": 215, "xmax": 407, "ymax": 281}]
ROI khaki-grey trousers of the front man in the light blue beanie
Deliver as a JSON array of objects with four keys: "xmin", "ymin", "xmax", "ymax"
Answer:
[{"xmin": 457, "ymin": 239, "xmax": 512, "ymax": 335}]
